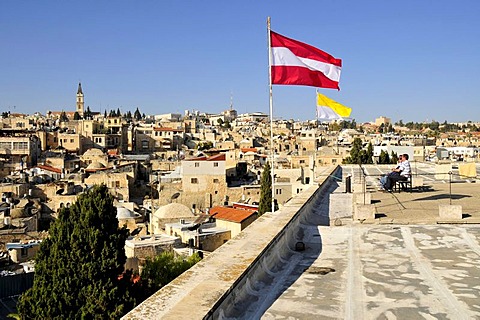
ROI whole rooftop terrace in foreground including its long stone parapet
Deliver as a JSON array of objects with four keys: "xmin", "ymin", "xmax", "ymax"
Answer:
[{"xmin": 125, "ymin": 164, "xmax": 480, "ymax": 319}]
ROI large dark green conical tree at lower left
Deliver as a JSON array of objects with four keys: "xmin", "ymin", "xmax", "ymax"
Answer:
[{"xmin": 18, "ymin": 185, "xmax": 134, "ymax": 319}]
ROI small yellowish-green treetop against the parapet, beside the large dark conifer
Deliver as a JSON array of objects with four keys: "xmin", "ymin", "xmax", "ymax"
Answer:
[{"xmin": 138, "ymin": 252, "xmax": 200, "ymax": 300}]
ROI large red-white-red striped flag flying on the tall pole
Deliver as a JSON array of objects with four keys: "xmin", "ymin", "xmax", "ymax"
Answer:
[{"xmin": 270, "ymin": 31, "xmax": 342, "ymax": 90}]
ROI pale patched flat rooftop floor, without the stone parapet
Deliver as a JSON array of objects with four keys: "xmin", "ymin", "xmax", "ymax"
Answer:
[{"xmin": 262, "ymin": 165, "xmax": 480, "ymax": 319}]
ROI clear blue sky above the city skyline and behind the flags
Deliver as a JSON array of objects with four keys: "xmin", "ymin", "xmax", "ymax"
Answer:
[{"xmin": 0, "ymin": 0, "xmax": 480, "ymax": 122}]
